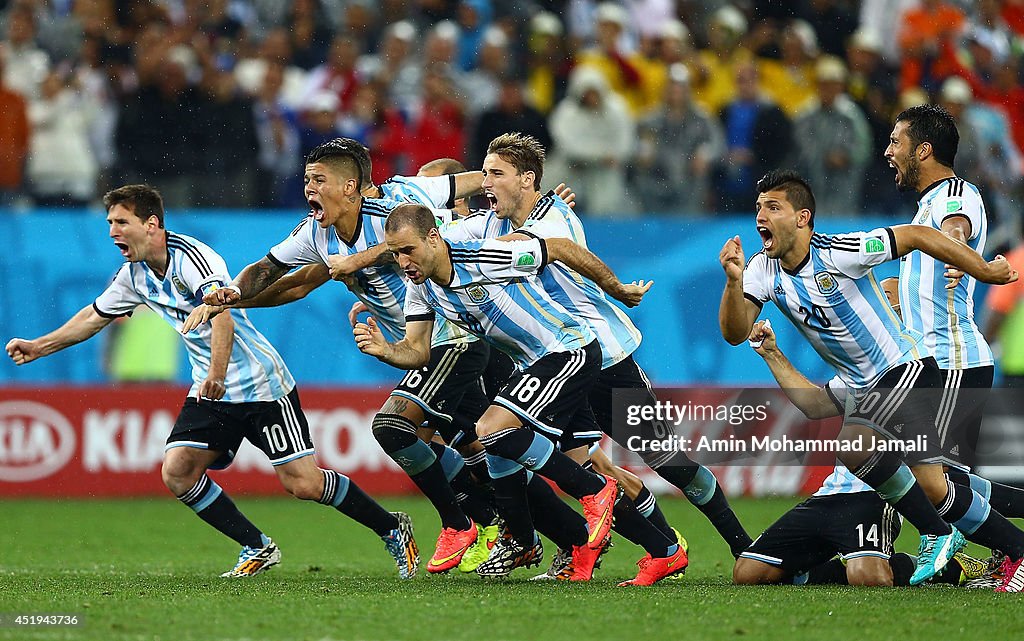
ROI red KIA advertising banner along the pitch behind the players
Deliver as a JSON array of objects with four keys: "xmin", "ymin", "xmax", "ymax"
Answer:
[{"xmin": 0, "ymin": 385, "xmax": 830, "ymax": 498}]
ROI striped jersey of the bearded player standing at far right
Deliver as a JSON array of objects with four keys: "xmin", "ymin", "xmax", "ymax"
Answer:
[{"xmin": 899, "ymin": 177, "xmax": 992, "ymax": 370}]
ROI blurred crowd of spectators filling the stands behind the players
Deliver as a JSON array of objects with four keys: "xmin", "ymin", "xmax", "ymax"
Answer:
[{"xmin": 0, "ymin": 0, "xmax": 1024, "ymax": 234}]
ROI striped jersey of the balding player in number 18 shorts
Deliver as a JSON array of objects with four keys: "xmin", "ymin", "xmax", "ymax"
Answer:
[{"xmin": 406, "ymin": 235, "xmax": 595, "ymax": 369}]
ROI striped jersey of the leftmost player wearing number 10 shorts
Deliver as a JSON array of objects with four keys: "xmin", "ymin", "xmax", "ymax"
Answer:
[{"xmin": 92, "ymin": 231, "xmax": 295, "ymax": 402}]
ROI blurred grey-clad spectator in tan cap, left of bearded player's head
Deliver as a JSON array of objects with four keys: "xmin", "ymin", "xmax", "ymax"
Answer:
[{"xmin": 794, "ymin": 55, "xmax": 878, "ymax": 216}]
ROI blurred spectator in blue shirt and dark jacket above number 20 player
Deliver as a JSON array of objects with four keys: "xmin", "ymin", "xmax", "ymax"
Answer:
[{"xmin": 715, "ymin": 60, "xmax": 794, "ymax": 213}]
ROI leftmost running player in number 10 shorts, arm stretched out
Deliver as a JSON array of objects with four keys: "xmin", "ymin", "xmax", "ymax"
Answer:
[{"xmin": 7, "ymin": 184, "xmax": 419, "ymax": 579}]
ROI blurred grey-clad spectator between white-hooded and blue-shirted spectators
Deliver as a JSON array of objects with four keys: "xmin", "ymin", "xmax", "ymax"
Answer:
[{"xmin": 631, "ymin": 62, "xmax": 725, "ymax": 214}]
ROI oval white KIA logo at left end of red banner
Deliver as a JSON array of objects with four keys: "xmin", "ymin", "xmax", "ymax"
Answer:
[{"xmin": 0, "ymin": 400, "xmax": 75, "ymax": 482}]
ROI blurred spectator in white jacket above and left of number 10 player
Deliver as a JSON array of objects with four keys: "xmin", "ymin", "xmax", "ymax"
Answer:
[{"xmin": 26, "ymin": 72, "xmax": 99, "ymax": 207}]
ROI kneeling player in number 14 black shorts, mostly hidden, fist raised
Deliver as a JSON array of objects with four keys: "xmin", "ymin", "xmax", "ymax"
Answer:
[{"xmin": 732, "ymin": 321, "xmax": 999, "ymax": 588}]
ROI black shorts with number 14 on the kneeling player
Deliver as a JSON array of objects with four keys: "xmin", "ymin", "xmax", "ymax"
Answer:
[{"xmin": 739, "ymin": 492, "xmax": 900, "ymax": 574}]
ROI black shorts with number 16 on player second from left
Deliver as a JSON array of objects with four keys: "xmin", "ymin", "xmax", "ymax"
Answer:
[{"xmin": 391, "ymin": 340, "xmax": 490, "ymax": 421}]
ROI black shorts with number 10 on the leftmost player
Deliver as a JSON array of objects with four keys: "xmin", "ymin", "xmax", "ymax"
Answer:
[{"xmin": 164, "ymin": 388, "xmax": 314, "ymax": 470}]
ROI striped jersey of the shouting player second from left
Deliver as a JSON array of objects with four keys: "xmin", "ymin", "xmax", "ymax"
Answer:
[{"xmin": 267, "ymin": 199, "xmax": 473, "ymax": 346}]
